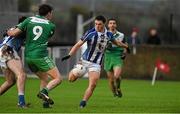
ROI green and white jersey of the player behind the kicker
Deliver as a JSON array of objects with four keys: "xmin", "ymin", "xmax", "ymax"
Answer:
[{"xmin": 105, "ymin": 31, "xmax": 124, "ymax": 56}]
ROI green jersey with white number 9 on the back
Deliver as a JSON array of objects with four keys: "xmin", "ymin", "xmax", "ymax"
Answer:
[{"xmin": 18, "ymin": 15, "xmax": 55, "ymax": 58}]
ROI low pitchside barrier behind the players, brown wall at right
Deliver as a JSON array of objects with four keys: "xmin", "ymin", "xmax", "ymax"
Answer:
[{"xmin": 1, "ymin": 45, "xmax": 180, "ymax": 80}]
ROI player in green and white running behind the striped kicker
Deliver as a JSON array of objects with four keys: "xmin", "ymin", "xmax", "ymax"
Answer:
[{"xmin": 104, "ymin": 19, "xmax": 128, "ymax": 97}]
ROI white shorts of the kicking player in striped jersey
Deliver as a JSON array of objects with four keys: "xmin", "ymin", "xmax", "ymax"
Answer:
[{"xmin": 81, "ymin": 59, "xmax": 101, "ymax": 73}]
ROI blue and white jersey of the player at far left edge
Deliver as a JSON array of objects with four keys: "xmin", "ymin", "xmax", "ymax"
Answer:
[{"xmin": 0, "ymin": 36, "xmax": 25, "ymax": 52}]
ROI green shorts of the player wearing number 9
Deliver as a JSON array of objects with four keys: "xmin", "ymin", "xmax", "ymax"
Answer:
[{"xmin": 25, "ymin": 57, "xmax": 55, "ymax": 72}]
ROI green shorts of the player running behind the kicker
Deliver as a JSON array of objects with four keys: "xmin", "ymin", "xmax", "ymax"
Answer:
[{"xmin": 104, "ymin": 54, "xmax": 123, "ymax": 71}]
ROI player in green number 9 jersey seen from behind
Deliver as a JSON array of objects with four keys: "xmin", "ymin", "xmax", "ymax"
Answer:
[{"xmin": 8, "ymin": 4, "xmax": 62, "ymax": 107}]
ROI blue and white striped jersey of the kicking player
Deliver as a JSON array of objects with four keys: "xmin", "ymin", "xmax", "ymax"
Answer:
[{"xmin": 81, "ymin": 28, "xmax": 114, "ymax": 64}]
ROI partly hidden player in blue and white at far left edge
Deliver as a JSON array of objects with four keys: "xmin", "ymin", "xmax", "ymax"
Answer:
[{"xmin": 0, "ymin": 17, "xmax": 27, "ymax": 108}]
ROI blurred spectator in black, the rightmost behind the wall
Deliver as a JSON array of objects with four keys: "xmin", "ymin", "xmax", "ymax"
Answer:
[{"xmin": 147, "ymin": 28, "xmax": 161, "ymax": 45}]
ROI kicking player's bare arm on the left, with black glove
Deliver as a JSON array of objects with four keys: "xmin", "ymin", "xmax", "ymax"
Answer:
[{"xmin": 61, "ymin": 40, "xmax": 84, "ymax": 61}]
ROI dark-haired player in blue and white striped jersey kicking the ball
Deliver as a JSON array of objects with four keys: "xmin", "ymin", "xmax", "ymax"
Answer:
[{"xmin": 62, "ymin": 15, "xmax": 128, "ymax": 108}]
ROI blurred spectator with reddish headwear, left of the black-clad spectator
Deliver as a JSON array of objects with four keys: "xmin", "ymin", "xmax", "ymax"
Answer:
[{"xmin": 127, "ymin": 27, "xmax": 140, "ymax": 45}]
